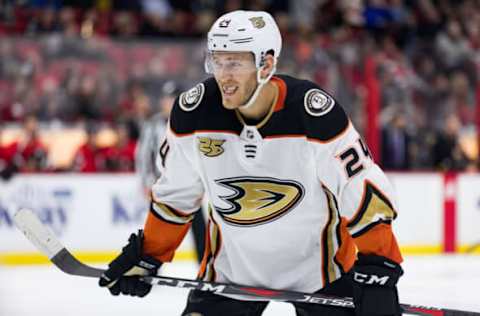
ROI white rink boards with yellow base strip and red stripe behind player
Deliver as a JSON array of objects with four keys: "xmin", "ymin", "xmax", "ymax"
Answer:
[{"xmin": 0, "ymin": 173, "xmax": 480, "ymax": 264}]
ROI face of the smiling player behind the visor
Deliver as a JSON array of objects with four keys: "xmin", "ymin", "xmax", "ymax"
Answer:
[{"xmin": 211, "ymin": 52, "xmax": 257, "ymax": 110}]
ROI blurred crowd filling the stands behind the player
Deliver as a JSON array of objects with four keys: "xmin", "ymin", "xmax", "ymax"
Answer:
[{"xmin": 0, "ymin": 0, "xmax": 480, "ymax": 178}]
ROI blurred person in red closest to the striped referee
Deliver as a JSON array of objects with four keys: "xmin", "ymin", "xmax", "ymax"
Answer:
[{"xmin": 105, "ymin": 123, "xmax": 137, "ymax": 172}]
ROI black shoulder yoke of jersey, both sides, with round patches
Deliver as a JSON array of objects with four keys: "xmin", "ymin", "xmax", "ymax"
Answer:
[{"xmin": 170, "ymin": 75, "xmax": 348, "ymax": 141}]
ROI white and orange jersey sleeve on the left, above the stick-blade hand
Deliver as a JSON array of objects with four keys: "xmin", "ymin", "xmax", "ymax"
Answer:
[{"xmin": 144, "ymin": 116, "xmax": 204, "ymax": 262}]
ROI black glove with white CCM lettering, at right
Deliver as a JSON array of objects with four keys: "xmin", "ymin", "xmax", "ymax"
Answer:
[{"xmin": 350, "ymin": 253, "xmax": 403, "ymax": 316}]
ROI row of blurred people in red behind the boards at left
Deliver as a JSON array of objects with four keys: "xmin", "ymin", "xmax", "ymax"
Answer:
[{"xmin": 0, "ymin": 116, "xmax": 137, "ymax": 180}]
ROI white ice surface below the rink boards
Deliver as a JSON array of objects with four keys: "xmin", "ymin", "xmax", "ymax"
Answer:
[{"xmin": 0, "ymin": 255, "xmax": 480, "ymax": 316}]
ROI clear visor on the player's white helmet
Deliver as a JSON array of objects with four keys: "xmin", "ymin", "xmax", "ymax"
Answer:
[{"xmin": 205, "ymin": 51, "xmax": 257, "ymax": 76}]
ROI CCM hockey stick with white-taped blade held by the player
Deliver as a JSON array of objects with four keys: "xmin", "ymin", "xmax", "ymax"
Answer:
[{"xmin": 13, "ymin": 209, "xmax": 480, "ymax": 316}]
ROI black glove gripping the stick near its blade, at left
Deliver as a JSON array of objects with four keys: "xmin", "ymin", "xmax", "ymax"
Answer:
[{"xmin": 98, "ymin": 230, "xmax": 162, "ymax": 297}]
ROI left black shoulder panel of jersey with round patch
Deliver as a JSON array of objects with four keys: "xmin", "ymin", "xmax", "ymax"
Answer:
[{"xmin": 170, "ymin": 78, "xmax": 241, "ymax": 134}]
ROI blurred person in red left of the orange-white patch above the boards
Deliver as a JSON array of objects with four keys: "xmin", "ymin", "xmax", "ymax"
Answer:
[{"xmin": 17, "ymin": 116, "xmax": 48, "ymax": 172}]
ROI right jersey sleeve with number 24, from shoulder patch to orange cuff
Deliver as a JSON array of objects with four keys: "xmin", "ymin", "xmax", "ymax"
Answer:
[{"xmin": 304, "ymin": 89, "xmax": 402, "ymax": 263}]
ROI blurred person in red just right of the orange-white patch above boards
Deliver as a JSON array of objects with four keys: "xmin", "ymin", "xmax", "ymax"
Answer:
[{"xmin": 71, "ymin": 126, "xmax": 104, "ymax": 173}]
